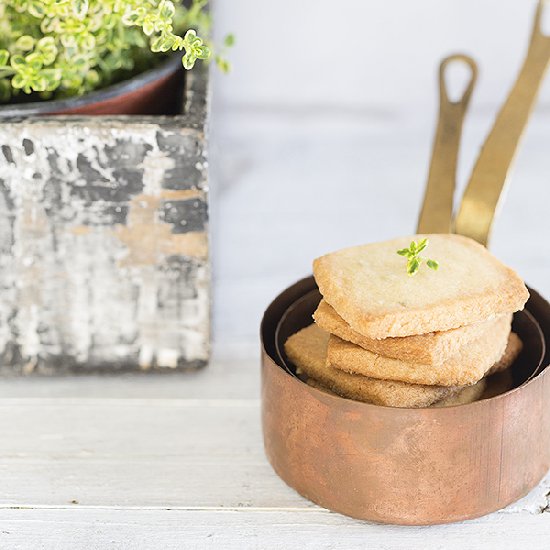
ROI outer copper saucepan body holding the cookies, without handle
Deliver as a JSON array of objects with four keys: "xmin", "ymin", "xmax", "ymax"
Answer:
[{"xmin": 261, "ymin": 278, "xmax": 550, "ymax": 525}]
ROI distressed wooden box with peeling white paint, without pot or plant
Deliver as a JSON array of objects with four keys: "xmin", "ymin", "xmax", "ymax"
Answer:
[{"xmin": 0, "ymin": 68, "xmax": 209, "ymax": 374}]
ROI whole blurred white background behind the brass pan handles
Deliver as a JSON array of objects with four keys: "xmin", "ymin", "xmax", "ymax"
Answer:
[{"xmin": 211, "ymin": 0, "xmax": 550, "ymax": 349}]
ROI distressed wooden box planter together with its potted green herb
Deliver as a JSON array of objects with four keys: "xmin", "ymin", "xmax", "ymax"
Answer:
[{"xmin": 0, "ymin": 0, "xmax": 232, "ymax": 374}]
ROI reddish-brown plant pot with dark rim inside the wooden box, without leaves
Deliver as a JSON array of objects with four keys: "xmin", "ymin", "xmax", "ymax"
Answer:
[{"xmin": 0, "ymin": 55, "xmax": 185, "ymax": 119}]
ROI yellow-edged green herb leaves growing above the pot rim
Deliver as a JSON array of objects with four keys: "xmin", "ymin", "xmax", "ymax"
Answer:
[{"xmin": 0, "ymin": 0, "xmax": 232, "ymax": 102}]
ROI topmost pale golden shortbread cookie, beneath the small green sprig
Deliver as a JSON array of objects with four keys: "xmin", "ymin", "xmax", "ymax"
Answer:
[{"xmin": 313, "ymin": 234, "xmax": 529, "ymax": 339}]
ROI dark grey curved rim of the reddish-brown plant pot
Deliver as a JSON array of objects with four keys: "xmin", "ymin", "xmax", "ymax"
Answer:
[{"xmin": 0, "ymin": 54, "xmax": 182, "ymax": 119}]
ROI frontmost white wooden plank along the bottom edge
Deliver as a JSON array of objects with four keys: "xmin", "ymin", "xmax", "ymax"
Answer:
[{"xmin": 0, "ymin": 505, "xmax": 550, "ymax": 550}]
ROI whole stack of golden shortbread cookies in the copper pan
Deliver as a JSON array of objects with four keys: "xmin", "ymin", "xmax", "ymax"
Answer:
[{"xmin": 285, "ymin": 235, "xmax": 529, "ymax": 407}]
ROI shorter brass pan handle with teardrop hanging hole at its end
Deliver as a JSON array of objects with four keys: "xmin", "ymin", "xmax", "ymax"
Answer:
[{"xmin": 417, "ymin": 54, "xmax": 477, "ymax": 233}]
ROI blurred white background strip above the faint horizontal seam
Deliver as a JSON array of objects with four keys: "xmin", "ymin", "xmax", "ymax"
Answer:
[{"xmin": 215, "ymin": 0, "xmax": 550, "ymax": 111}]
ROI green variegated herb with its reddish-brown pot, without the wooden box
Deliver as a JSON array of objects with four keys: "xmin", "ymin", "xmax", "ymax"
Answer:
[{"xmin": 0, "ymin": 0, "xmax": 231, "ymax": 116}]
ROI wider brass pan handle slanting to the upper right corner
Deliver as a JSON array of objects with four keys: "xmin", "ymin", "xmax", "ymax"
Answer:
[{"xmin": 454, "ymin": 0, "xmax": 550, "ymax": 245}]
